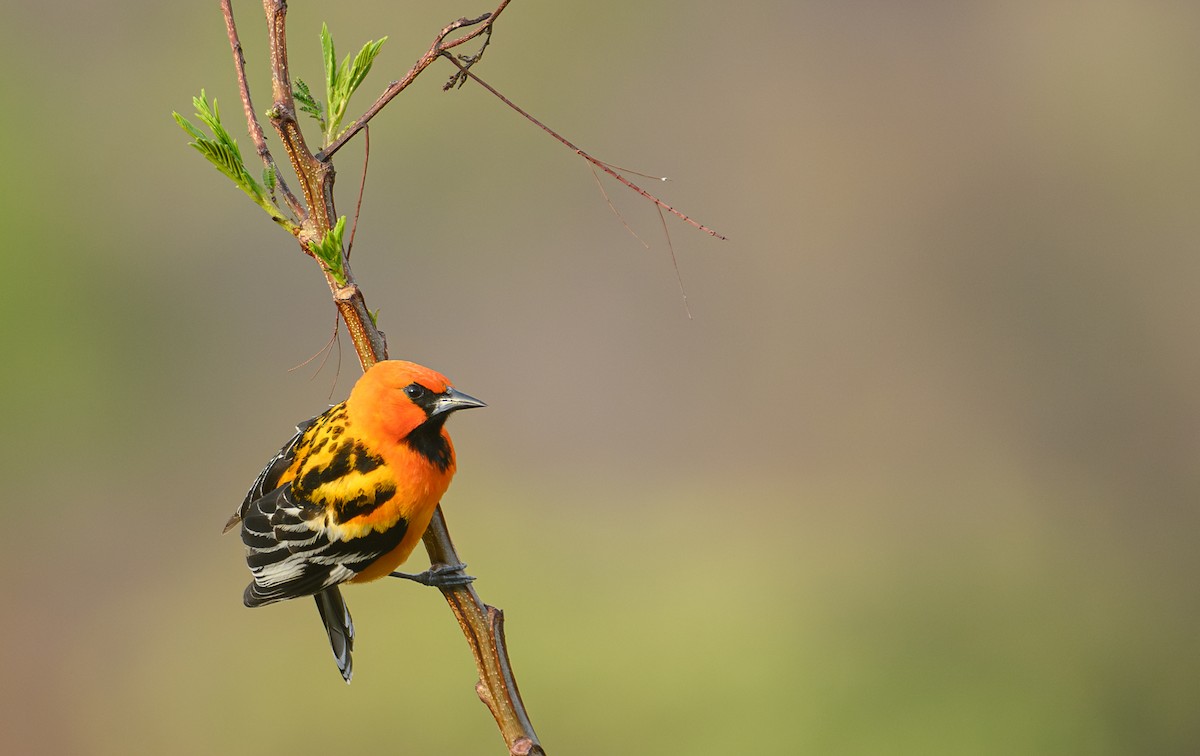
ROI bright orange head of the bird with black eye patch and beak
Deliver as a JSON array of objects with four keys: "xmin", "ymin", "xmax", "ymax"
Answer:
[{"xmin": 348, "ymin": 360, "xmax": 487, "ymax": 442}]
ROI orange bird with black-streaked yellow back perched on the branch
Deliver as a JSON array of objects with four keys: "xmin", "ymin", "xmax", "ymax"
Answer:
[{"xmin": 224, "ymin": 360, "xmax": 486, "ymax": 683}]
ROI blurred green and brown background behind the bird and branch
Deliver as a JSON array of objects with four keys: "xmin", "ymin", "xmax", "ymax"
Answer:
[{"xmin": 0, "ymin": 0, "xmax": 1200, "ymax": 755}]
